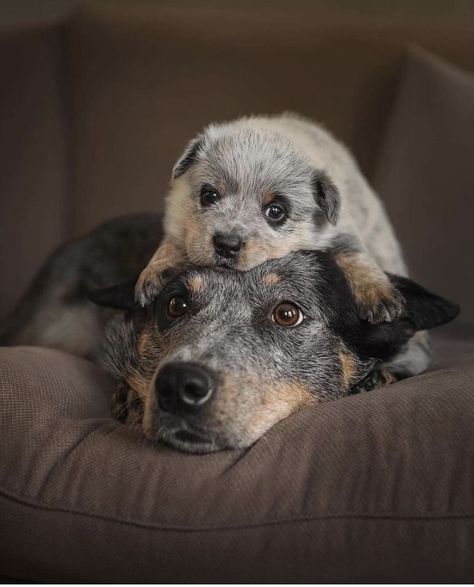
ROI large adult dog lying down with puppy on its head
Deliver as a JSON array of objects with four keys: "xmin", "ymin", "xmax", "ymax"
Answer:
[{"xmin": 0, "ymin": 214, "xmax": 458, "ymax": 452}]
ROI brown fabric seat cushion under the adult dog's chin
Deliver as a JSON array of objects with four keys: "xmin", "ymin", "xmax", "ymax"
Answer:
[{"xmin": 0, "ymin": 342, "xmax": 474, "ymax": 582}]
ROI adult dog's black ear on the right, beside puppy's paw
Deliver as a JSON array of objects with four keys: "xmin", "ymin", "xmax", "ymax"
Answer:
[{"xmin": 388, "ymin": 274, "xmax": 459, "ymax": 330}]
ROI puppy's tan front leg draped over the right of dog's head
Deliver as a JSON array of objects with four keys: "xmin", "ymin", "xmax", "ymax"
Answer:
[{"xmin": 335, "ymin": 249, "xmax": 404, "ymax": 324}]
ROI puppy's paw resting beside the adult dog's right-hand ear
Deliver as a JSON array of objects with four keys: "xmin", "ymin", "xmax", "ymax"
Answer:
[{"xmin": 355, "ymin": 282, "xmax": 405, "ymax": 324}]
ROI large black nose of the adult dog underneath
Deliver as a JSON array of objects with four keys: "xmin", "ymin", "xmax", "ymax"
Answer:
[{"xmin": 155, "ymin": 363, "xmax": 216, "ymax": 416}]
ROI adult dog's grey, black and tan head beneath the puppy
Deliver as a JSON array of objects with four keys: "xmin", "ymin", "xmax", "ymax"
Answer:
[{"xmin": 93, "ymin": 251, "xmax": 456, "ymax": 452}]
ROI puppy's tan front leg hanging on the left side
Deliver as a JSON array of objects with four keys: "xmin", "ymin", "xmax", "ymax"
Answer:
[{"xmin": 135, "ymin": 240, "xmax": 185, "ymax": 307}]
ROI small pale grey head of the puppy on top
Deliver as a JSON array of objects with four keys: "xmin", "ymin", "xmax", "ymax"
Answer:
[{"xmin": 165, "ymin": 119, "xmax": 340, "ymax": 270}]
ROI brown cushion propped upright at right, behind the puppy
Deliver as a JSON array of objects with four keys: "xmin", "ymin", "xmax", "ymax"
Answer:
[{"xmin": 375, "ymin": 50, "xmax": 474, "ymax": 330}]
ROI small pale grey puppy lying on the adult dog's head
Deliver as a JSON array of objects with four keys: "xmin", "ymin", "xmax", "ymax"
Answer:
[{"xmin": 136, "ymin": 114, "xmax": 429, "ymax": 375}]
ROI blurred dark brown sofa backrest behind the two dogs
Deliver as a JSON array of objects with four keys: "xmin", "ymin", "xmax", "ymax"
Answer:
[{"xmin": 0, "ymin": 0, "xmax": 474, "ymax": 330}]
